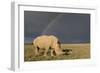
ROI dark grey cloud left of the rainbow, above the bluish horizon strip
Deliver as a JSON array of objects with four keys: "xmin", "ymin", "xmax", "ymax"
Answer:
[{"xmin": 24, "ymin": 11, "xmax": 57, "ymax": 36}]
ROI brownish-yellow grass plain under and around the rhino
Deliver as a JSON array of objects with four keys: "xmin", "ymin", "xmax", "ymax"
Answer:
[{"xmin": 24, "ymin": 43, "xmax": 90, "ymax": 61}]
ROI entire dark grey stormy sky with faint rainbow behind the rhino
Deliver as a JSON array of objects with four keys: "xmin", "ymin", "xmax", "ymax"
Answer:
[{"xmin": 24, "ymin": 11, "xmax": 90, "ymax": 43}]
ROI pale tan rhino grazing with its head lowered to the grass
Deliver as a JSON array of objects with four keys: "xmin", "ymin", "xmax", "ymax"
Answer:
[{"xmin": 33, "ymin": 35, "xmax": 65, "ymax": 56}]
